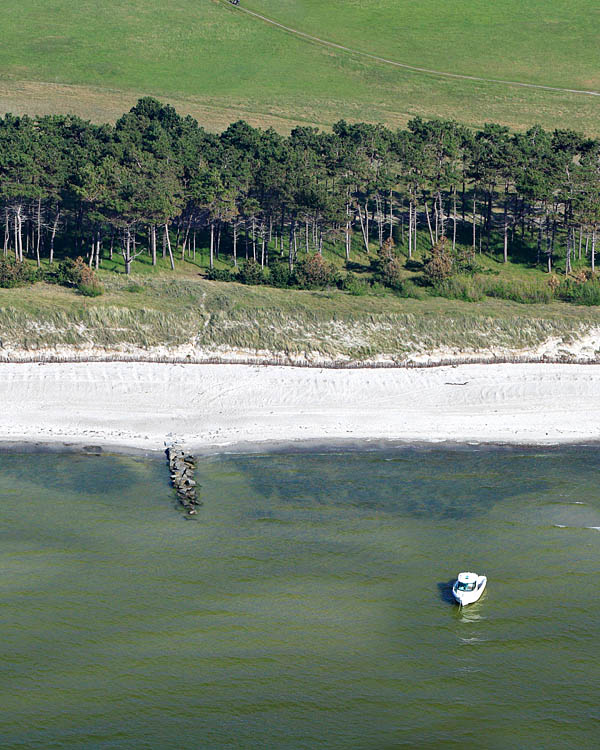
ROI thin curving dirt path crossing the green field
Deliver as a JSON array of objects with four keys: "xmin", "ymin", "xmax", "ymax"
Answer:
[{"xmin": 222, "ymin": 0, "xmax": 600, "ymax": 96}]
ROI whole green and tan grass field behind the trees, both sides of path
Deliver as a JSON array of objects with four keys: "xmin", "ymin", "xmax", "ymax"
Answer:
[{"xmin": 0, "ymin": 0, "xmax": 600, "ymax": 135}]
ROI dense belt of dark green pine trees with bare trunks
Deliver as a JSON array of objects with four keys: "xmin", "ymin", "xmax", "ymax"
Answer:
[{"xmin": 0, "ymin": 98, "xmax": 600, "ymax": 290}]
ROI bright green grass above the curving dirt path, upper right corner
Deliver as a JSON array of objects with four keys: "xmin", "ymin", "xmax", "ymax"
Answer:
[{"xmin": 244, "ymin": 0, "xmax": 600, "ymax": 91}]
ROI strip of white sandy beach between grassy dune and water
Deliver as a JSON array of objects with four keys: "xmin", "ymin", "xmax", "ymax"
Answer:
[{"xmin": 0, "ymin": 362, "xmax": 600, "ymax": 450}]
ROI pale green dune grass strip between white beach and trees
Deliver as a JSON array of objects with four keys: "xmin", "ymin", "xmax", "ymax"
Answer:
[{"xmin": 0, "ymin": 272, "xmax": 600, "ymax": 361}]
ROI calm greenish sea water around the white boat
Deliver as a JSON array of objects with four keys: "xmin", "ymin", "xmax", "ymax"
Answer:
[{"xmin": 0, "ymin": 448, "xmax": 600, "ymax": 750}]
